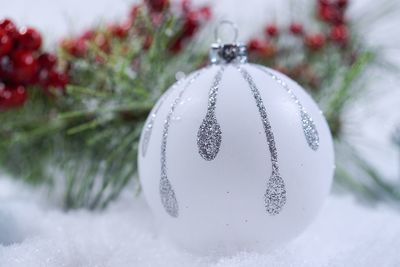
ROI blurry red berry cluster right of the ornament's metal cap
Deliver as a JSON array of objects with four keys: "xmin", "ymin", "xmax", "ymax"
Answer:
[{"xmin": 247, "ymin": 0, "xmax": 351, "ymax": 88}]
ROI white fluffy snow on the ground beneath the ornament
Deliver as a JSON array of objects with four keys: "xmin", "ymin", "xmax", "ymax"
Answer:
[{"xmin": 0, "ymin": 177, "xmax": 400, "ymax": 267}]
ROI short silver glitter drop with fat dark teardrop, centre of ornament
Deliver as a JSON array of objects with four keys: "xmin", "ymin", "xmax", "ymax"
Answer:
[{"xmin": 197, "ymin": 67, "xmax": 224, "ymax": 161}]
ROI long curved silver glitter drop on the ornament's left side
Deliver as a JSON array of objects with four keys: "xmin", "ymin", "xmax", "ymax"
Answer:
[{"xmin": 160, "ymin": 71, "xmax": 202, "ymax": 218}]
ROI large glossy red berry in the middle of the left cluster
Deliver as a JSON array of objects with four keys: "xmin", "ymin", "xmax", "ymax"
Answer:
[{"xmin": 11, "ymin": 50, "xmax": 39, "ymax": 84}]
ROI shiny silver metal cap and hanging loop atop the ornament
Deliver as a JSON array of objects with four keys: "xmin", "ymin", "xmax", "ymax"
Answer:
[{"xmin": 209, "ymin": 20, "xmax": 247, "ymax": 64}]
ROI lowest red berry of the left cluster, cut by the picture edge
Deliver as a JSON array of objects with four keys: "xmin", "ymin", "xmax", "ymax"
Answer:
[{"xmin": 0, "ymin": 85, "xmax": 28, "ymax": 110}]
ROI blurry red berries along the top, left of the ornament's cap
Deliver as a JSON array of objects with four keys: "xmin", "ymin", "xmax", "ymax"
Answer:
[{"xmin": 61, "ymin": 0, "xmax": 211, "ymax": 59}]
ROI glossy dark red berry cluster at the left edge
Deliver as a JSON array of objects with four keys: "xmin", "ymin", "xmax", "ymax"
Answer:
[{"xmin": 0, "ymin": 19, "xmax": 68, "ymax": 110}]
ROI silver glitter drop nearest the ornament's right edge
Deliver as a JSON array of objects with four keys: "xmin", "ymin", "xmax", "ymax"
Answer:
[{"xmin": 256, "ymin": 66, "xmax": 319, "ymax": 150}]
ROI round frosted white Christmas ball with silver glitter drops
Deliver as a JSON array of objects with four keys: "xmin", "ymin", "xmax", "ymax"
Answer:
[{"xmin": 139, "ymin": 63, "xmax": 334, "ymax": 254}]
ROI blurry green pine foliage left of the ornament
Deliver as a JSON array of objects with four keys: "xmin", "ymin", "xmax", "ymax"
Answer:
[{"xmin": 0, "ymin": 6, "xmax": 205, "ymax": 209}]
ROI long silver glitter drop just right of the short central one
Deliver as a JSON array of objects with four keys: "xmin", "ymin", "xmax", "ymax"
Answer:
[{"xmin": 237, "ymin": 65, "xmax": 286, "ymax": 215}]
